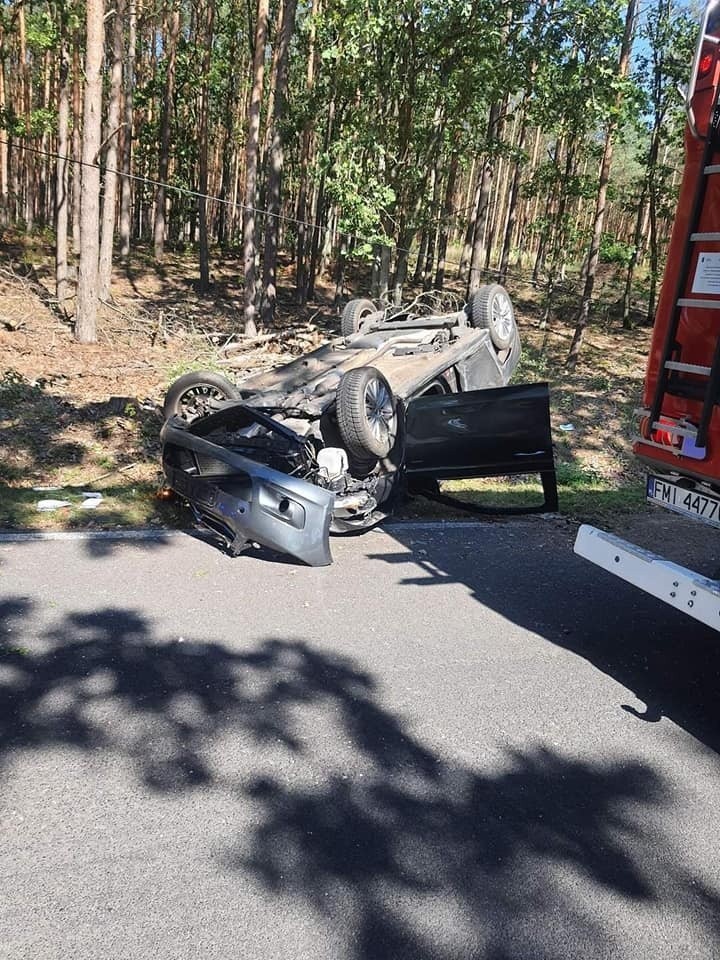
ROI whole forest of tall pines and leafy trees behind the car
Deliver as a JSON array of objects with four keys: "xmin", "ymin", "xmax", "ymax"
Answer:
[{"xmin": 0, "ymin": 0, "xmax": 697, "ymax": 363}]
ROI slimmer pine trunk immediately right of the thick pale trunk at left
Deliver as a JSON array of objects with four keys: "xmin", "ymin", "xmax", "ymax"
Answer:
[{"xmin": 98, "ymin": 0, "xmax": 125, "ymax": 300}]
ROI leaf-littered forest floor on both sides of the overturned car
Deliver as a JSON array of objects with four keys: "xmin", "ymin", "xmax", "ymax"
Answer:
[{"xmin": 0, "ymin": 235, "xmax": 650, "ymax": 529}]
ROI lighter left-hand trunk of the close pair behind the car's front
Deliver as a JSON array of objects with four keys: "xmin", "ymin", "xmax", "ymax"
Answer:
[{"xmin": 243, "ymin": 0, "xmax": 268, "ymax": 336}]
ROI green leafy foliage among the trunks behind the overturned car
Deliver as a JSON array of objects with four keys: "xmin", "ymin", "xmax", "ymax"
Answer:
[{"xmin": 0, "ymin": 0, "xmax": 696, "ymax": 322}]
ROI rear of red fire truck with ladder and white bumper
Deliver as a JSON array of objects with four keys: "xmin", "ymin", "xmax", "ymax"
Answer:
[{"xmin": 575, "ymin": 0, "xmax": 720, "ymax": 630}]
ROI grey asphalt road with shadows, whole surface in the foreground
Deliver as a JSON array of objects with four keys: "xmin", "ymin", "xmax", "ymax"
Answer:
[{"xmin": 0, "ymin": 521, "xmax": 720, "ymax": 960}]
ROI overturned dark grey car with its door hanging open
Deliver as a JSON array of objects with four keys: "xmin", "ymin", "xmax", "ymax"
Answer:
[{"xmin": 161, "ymin": 284, "xmax": 552, "ymax": 566}]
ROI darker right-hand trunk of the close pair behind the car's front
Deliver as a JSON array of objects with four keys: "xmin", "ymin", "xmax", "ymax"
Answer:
[{"xmin": 262, "ymin": 0, "xmax": 297, "ymax": 325}]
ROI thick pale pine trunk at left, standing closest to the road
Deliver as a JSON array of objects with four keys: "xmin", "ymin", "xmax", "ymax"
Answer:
[{"xmin": 75, "ymin": 0, "xmax": 105, "ymax": 343}]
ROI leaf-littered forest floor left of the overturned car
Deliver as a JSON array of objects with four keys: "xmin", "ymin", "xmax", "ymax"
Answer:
[{"xmin": 0, "ymin": 238, "xmax": 336, "ymax": 528}]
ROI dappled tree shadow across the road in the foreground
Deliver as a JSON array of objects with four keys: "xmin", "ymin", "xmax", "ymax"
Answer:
[{"xmin": 0, "ymin": 598, "xmax": 720, "ymax": 960}]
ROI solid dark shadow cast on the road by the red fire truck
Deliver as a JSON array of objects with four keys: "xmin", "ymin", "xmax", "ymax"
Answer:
[{"xmin": 370, "ymin": 520, "xmax": 720, "ymax": 752}]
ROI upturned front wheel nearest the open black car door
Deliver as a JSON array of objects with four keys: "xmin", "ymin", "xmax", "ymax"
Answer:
[{"xmin": 336, "ymin": 367, "xmax": 397, "ymax": 462}]
